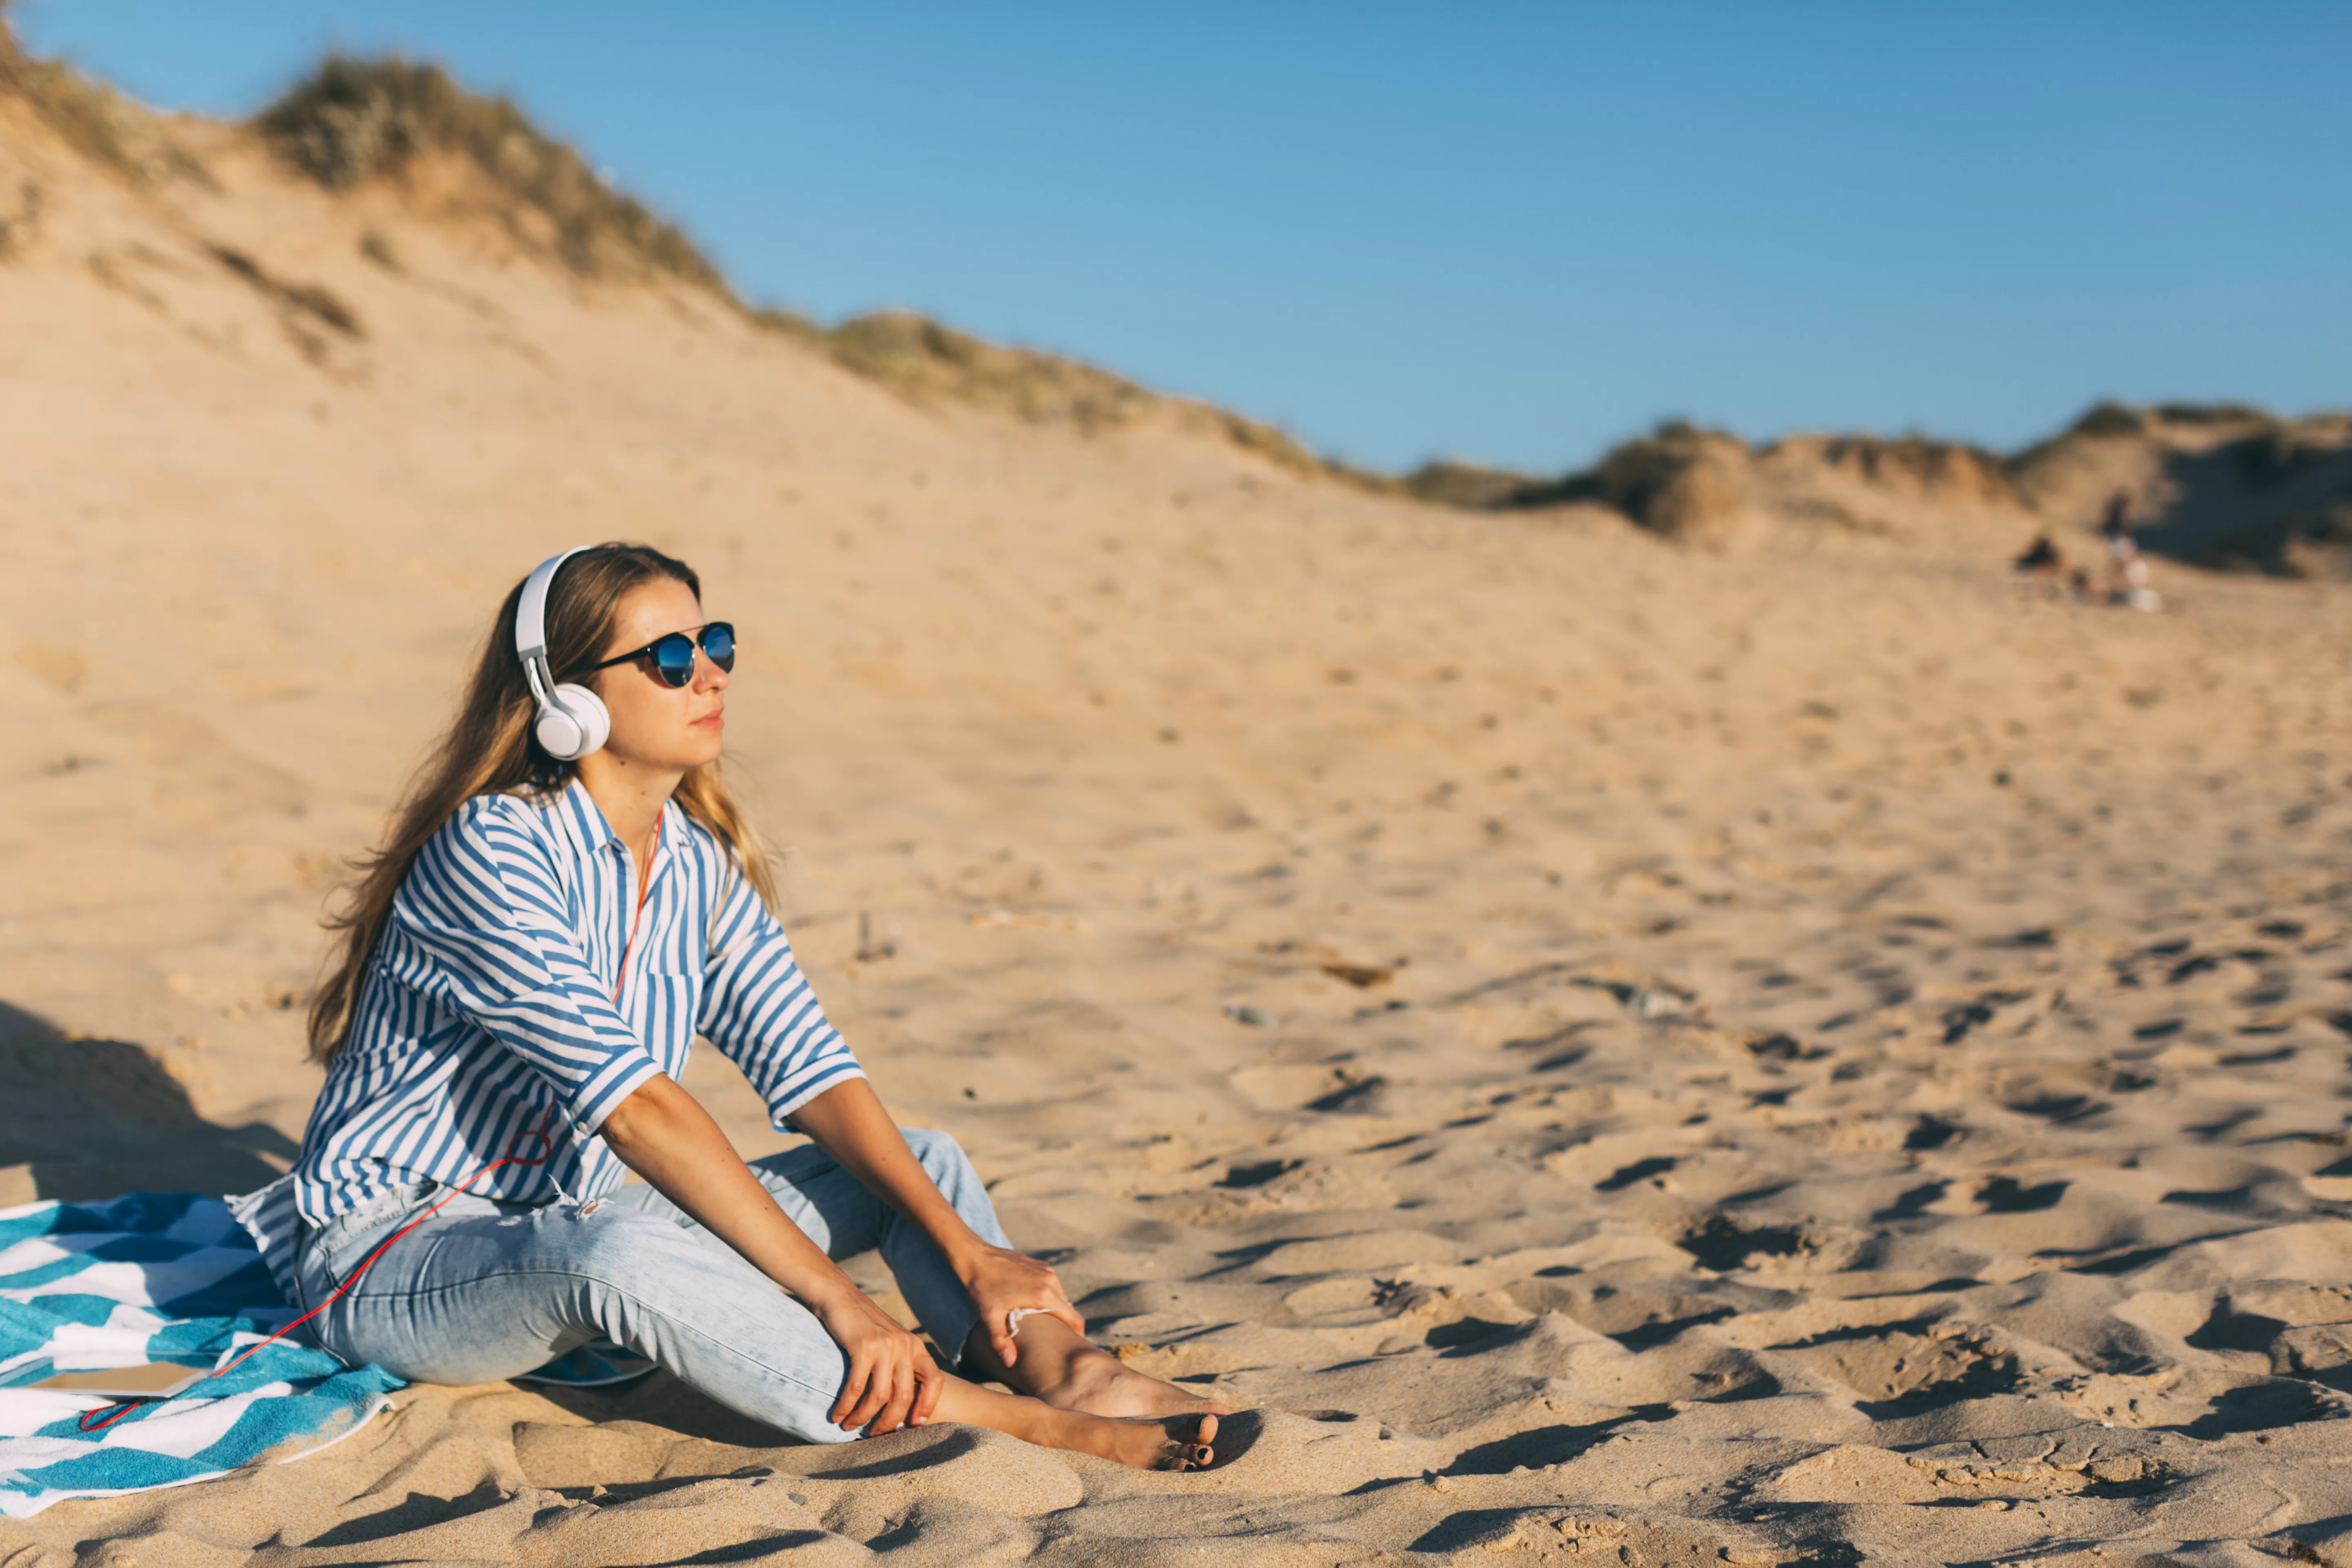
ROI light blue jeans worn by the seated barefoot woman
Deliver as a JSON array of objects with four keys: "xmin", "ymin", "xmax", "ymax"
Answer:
[{"xmin": 299, "ymin": 1128, "xmax": 1007, "ymax": 1443}]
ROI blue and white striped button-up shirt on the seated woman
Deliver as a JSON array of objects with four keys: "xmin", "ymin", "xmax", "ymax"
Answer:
[{"xmin": 281, "ymin": 780, "xmax": 866, "ymax": 1251}]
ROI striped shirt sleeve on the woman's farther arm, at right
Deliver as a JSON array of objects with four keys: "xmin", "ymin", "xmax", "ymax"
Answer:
[{"xmin": 696, "ymin": 875, "xmax": 866, "ymax": 1128}]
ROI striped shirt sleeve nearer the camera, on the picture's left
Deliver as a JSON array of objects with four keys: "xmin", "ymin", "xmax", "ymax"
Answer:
[{"xmin": 393, "ymin": 797, "xmax": 661, "ymax": 1133}]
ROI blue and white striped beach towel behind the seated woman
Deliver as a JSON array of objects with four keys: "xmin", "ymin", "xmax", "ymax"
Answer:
[{"xmin": 0, "ymin": 1192, "xmax": 400, "ymax": 1519}]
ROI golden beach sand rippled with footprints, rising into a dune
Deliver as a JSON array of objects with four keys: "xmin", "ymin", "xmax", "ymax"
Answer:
[{"xmin": 0, "ymin": 86, "xmax": 2352, "ymax": 1568}]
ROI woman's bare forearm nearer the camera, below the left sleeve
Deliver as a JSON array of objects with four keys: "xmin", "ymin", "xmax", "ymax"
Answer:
[{"xmin": 597, "ymin": 1074, "xmax": 870, "ymax": 1307}]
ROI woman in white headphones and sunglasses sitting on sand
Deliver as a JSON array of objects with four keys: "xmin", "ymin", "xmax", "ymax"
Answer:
[{"xmin": 269, "ymin": 546, "xmax": 1230, "ymax": 1469}]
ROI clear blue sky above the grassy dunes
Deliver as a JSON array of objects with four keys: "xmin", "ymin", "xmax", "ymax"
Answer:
[{"xmin": 16, "ymin": 0, "xmax": 2352, "ymax": 472}]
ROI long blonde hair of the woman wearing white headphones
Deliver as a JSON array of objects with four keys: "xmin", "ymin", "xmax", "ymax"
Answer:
[{"xmin": 310, "ymin": 543, "xmax": 776, "ymax": 1062}]
